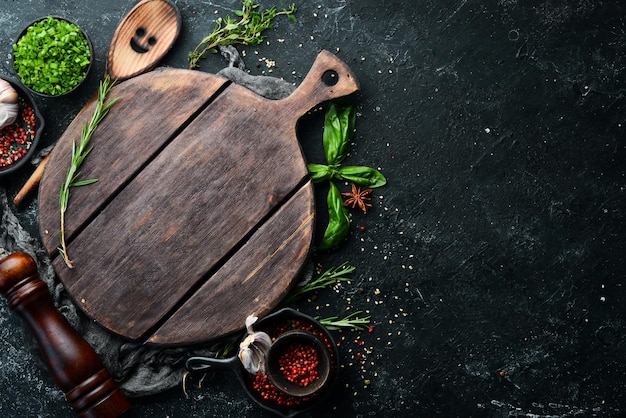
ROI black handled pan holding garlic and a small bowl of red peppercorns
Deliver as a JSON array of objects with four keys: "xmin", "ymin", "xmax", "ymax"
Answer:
[{"xmin": 183, "ymin": 308, "xmax": 339, "ymax": 418}]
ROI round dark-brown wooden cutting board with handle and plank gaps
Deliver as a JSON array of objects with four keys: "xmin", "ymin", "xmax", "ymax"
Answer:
[{"xmin": 39, "ymin": 51, "xmax": 359, "ymax": 345}]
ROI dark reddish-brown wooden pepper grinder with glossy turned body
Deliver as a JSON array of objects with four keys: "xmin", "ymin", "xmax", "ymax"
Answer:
[{"xmin": 0, "ymin": 252, "xmax": 130, "ymax": 418}]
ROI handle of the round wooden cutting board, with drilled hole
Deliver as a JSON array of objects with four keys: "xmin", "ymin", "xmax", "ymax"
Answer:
[{"xmin": 280, "ymin": 50, "xmax": 360, "ymax": 119}]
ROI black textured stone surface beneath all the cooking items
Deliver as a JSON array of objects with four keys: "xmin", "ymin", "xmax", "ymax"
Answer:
[{"xmin": 0, "ymin": 0, "xmax": 626, "ymax": 418}]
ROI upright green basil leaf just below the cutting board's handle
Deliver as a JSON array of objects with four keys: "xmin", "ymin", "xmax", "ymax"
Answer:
[{"xmin": 323, "ymin": 103, "xmax": 356, "ymax": 165}]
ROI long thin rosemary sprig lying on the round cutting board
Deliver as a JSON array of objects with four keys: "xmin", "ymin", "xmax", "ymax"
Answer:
[{"xmin": 59, "ymin": 76, "xmax": 118, "ymax": 268}]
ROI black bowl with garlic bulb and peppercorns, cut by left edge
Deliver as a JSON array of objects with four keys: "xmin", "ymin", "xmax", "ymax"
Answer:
[{"xmin": 0, "ymin": 75, "xmax": 44, "ymax": 176}]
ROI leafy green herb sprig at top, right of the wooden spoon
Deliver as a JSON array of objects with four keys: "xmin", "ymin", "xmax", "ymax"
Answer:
[{"xmin": 187, "ymin": 0, "xmax": 297, "ymax": 69}]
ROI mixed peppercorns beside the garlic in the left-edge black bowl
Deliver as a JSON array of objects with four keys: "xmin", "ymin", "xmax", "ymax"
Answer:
[{"xmin": 0, "ymin": 98, "xmax": 37, "ymax": 170}]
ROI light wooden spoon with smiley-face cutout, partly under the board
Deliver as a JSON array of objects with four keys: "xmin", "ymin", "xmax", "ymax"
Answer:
[{"xmin": 13, "ymin": 0, "xmax": 182, "ymax": 207}]
